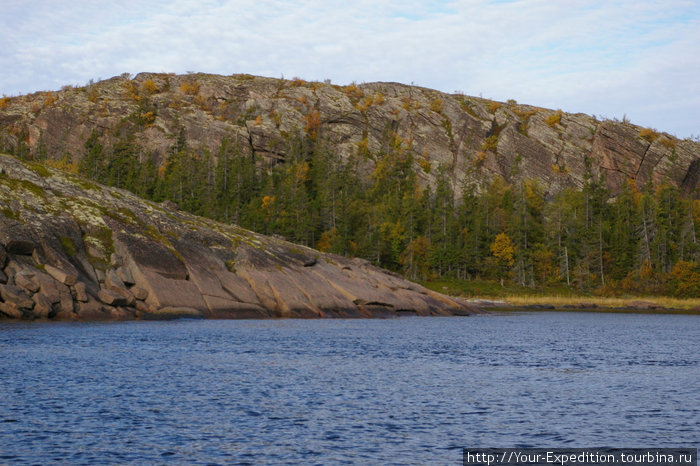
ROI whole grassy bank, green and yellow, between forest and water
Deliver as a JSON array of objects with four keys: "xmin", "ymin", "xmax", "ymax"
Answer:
[{"xmin": 423, "ymin": 279, "xmax": 700, "ymax": 314}]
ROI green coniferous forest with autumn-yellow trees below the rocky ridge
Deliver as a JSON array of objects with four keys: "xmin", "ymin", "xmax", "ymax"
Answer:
[{"xmin": 18, "ymin": 127, "xmax": 700, "ymax": 297}]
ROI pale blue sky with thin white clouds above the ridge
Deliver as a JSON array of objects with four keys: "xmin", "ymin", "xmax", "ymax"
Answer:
[{"xmin": 0, "ymin": 0, "xmax": 700, "ymax": 138}]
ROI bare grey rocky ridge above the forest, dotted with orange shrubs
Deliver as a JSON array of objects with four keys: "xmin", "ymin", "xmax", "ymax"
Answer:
[{"xmin": 0, "ymin": 73, "xmax": 700, "ymax": 193}]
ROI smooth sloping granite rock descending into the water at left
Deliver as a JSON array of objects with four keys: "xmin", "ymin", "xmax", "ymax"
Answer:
[{"xmin": 0, "ymin": 155, "xmax": 478, "ymax": 320}]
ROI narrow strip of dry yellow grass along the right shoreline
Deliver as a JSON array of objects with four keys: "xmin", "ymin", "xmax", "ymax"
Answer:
[{"xmin": 504, "ymin": 296, "xmax": 700, "ymax": 309}]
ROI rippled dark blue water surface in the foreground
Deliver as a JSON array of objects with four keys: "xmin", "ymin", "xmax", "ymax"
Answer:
[{"xmin": 0, "ymin": 312, "xmax": 700, "ymax": 464}]
